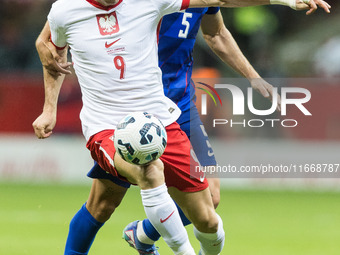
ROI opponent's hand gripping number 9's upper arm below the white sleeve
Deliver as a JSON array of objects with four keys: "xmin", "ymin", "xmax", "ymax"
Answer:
[{"xmin": 37, "ymin": 41, "xmax": 72, "ymax": 77}]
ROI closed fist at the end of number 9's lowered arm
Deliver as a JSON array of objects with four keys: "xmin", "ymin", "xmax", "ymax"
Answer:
[{"xmin": 32, "ymin": 112, "xmax": 56, "ymax": 139}]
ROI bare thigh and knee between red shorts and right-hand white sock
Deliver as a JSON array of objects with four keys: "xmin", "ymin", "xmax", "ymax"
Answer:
[{"xmin": 169, "ymin": 187, "xmax": 218, "ymax": 233}]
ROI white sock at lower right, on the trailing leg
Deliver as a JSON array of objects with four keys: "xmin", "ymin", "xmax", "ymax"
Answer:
[{"xmin": 194, "ymin": 214, "xmax": 225, "ymax": 255}]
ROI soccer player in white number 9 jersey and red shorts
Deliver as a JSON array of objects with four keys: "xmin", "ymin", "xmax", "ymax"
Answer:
[{"xmin": 34, "ymin": 0, "xmax": 328, "ymax": 254}]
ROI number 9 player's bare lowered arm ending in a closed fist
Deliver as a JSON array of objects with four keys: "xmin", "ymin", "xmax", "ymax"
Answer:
[{"xmin": 33, "ymin": 47, "xmax": 67, "ymax": 139}]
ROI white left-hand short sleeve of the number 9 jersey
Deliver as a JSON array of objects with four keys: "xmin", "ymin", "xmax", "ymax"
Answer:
[{"xmin": 47, "ymin": 2, "xmax": 67, "ymax": 49}]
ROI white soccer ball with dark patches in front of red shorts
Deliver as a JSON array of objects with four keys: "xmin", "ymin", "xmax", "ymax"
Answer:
[{"xmin": 113, "ymin": 112, "xmax": 167, "ymax": 165}]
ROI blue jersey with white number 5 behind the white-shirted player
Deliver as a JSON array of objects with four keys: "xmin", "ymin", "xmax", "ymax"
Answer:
[{"xmin": 158, "ymin": 7, "xmax": 219, "ymax": 112}]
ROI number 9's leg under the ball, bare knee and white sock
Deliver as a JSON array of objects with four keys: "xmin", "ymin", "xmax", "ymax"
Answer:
[{"xmin": 114, "ymin": 153, "xmax": 195, "ymax": 255}]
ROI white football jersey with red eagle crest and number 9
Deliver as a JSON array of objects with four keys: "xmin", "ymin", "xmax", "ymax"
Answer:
[{"xmin": 48, "ymin": 0, "xmax": 188, "ymax": 140}]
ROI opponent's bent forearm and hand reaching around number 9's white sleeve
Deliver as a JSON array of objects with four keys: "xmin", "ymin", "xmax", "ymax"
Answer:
[{"xmin": 35, "ymin": 21, "xmax": 72, "ymax": 76}]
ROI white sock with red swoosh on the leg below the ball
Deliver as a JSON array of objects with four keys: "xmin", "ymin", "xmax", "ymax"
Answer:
[{"xmin": 141, "ymin": 184, "xmax": 195, "ymax": 255}]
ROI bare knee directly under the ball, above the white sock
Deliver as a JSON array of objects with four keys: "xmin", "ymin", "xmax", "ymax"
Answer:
[{"xmin": 138, "ymin": 159, "xmax": 164, "ymax": 189}]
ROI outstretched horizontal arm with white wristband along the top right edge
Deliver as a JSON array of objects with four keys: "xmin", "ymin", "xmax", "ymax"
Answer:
[{"xmin": 184, "ymin": 0, "xmax": 331, "ymax": 15}]
